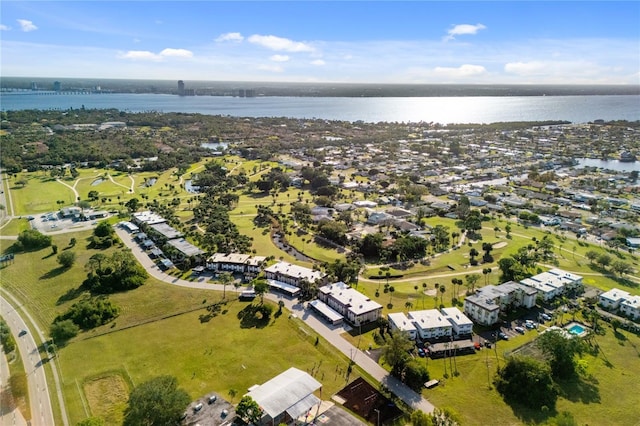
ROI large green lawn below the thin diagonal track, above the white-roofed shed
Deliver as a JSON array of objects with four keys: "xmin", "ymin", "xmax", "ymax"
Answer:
[{"xmin": 59, "ymin": 302, "xmax": 364, "ymax": 423}]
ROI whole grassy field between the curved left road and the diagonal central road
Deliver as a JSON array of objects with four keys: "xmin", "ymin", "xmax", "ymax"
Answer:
[{"xmin": 0, "ymin": 233, "xmax": 364, "ymax": 424}]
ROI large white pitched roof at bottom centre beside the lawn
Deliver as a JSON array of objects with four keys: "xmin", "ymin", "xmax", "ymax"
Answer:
[{"xmin": 247, "ymin": 367, "xmax": 322, "ymax": 418}]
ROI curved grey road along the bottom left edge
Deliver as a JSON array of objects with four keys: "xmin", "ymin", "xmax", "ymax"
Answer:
[{"xmin": 0, "ymin": 296, "xmax": 55, "ymax": 426}]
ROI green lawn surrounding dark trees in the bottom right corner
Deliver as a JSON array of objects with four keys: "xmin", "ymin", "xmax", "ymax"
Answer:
[{"xmin": 423, "ymin": 322, "xmax": 640, "ymax": 425}]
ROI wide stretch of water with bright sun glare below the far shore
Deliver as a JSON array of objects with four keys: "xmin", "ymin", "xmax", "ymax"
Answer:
[{"xmin": 0, "ymin": 92, "xmax": 640, "ymax": 124}]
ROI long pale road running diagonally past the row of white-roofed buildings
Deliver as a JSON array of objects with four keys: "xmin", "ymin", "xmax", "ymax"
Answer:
[{"xmin": 116, "ymin": 227, "xmax": 435, "ymax": 413}]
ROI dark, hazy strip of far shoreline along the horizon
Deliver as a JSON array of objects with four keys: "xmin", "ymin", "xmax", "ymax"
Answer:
[{"xmin": 0, "ymin": 77, "xmax": 640, "ymax": 98}]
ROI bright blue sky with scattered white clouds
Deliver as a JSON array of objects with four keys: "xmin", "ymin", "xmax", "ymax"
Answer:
[{"xmin": 0, "ymin": 0, "xmax": 640, "ymax": 84}]
